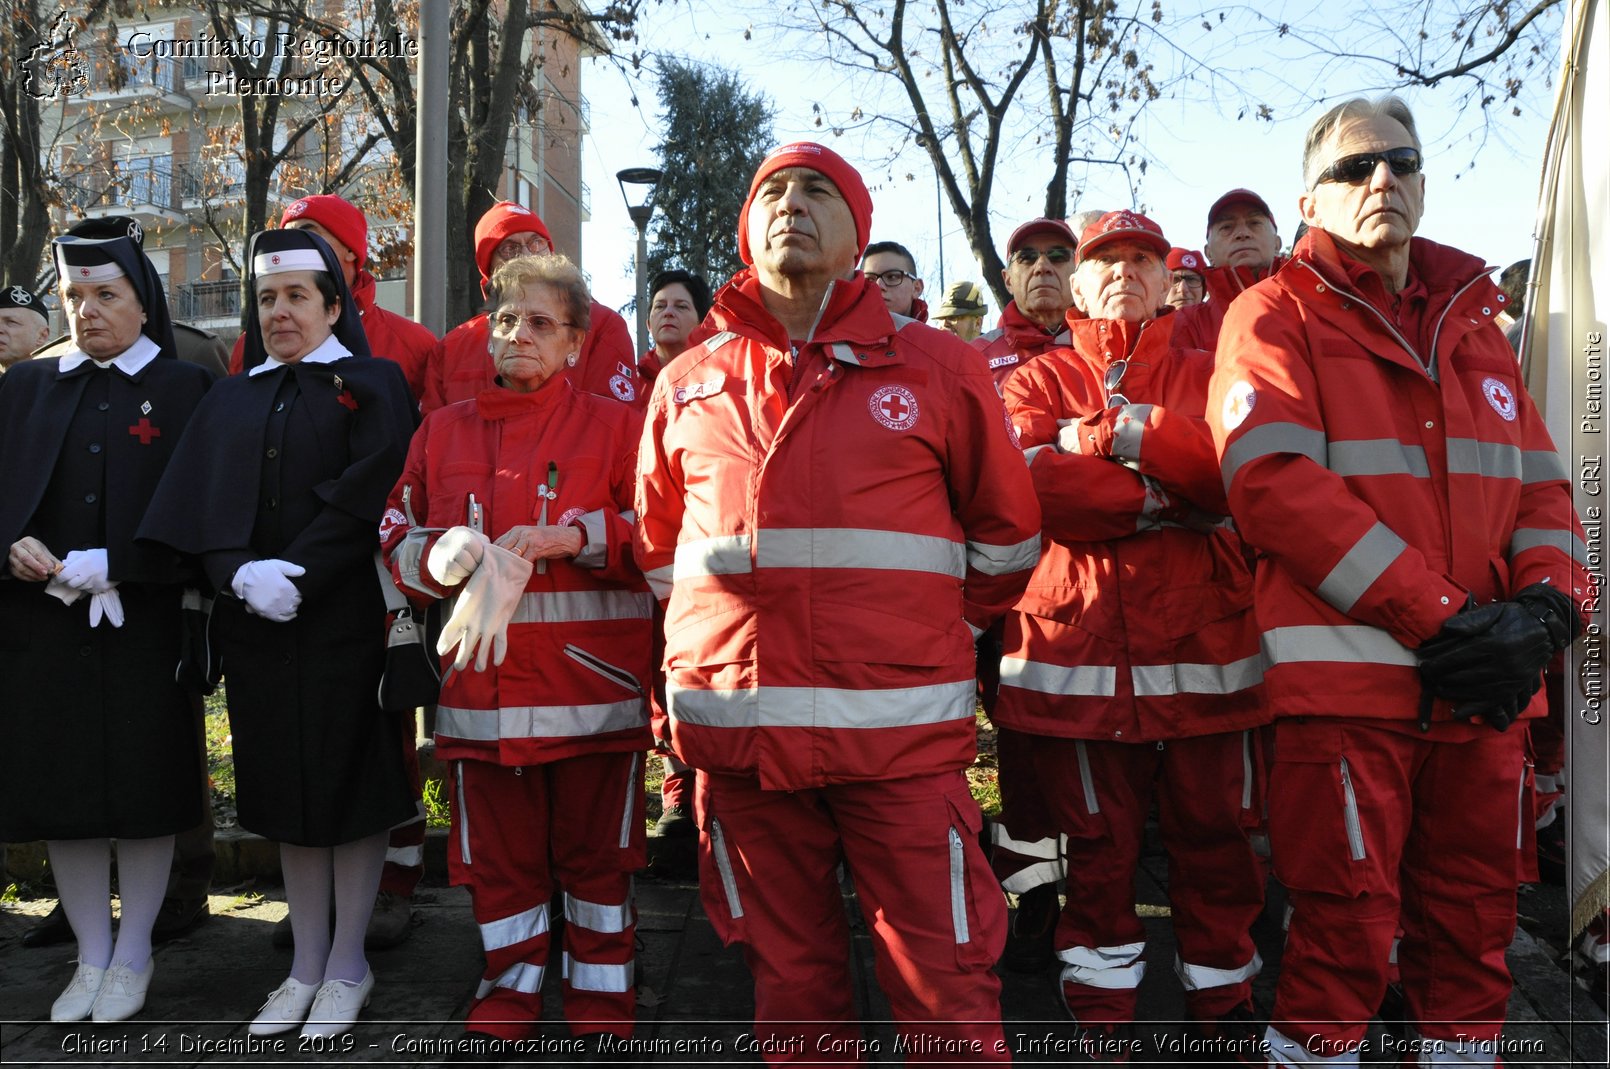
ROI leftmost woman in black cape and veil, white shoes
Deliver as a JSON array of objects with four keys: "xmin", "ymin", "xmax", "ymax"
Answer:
[{"xmin": 0, "ymin": 217, "xmax": 213, "ymax": 1021}]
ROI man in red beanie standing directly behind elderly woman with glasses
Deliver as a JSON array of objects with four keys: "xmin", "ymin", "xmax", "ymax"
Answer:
[{"xmin": 420, "ymin": 201, "xmax": 647, "ymax": 414}]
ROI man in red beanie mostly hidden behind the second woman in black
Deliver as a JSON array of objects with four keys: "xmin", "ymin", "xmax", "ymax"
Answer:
[{"xmin": 229, "ymin": 193, "xmax": 436, "ymax": 405}]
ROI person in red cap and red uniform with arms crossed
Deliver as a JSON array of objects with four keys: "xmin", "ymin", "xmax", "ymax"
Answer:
[{"xmin": 993, "ymin": 211, "xmax": 1269, "ymax": 1040}]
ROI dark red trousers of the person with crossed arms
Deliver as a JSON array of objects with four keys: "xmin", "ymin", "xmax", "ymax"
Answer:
[{"xmin": 1030, "ymin": 731, "xmax": 1264, "ymax": 1024}]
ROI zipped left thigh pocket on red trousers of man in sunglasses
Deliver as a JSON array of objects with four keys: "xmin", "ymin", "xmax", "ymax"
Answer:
[{"xmin": 1269, "ymin": 752, "xmax": 1370, "ymax": 898}]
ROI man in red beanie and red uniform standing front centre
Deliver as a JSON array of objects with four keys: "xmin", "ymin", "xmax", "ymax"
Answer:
[{"xmin": 636, "ymin": 142, "xmax": 1040, "ymax": 1063}]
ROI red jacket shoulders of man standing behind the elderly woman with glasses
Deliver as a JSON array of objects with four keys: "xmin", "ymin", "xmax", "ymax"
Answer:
[{"xmin": 419, "ymin": 301, "xmax": 649, "ymax": 415}]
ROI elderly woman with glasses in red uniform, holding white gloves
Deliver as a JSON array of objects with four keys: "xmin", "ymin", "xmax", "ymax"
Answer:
[{"xmin": 380, "ymin": 254, "xmax": 654, "ymax": 1048}]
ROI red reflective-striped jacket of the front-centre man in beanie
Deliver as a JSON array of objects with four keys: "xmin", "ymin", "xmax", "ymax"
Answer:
[{"xmin": 638, "ymin": 270, "xmax": 1040, "ymax": 790}]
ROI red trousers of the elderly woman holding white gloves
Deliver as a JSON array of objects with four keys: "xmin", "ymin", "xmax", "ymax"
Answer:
[{"xmin": 448, "ymin": 752, "xmax": 647, "ymax": 1040}]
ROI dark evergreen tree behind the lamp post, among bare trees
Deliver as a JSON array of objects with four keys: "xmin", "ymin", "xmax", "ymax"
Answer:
[{"xmin": 649, "ymin": 56, "xmax": 776, "ymax": 291}]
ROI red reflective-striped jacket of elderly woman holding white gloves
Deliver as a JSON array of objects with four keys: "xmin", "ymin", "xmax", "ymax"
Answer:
[{"xmin": 380, "ymin": 378, "xmax": 654, "ymax": 765}]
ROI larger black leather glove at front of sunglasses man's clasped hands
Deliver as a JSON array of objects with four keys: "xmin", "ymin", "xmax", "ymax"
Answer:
[{"xmin": 1417, "ymin": 602, "xmax": 1555, "ymax": 704}]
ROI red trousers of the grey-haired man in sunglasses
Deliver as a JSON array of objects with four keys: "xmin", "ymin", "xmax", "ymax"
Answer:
[{"xmin": 1269, "ymin": 718, "xmax": 1525, "ymax": 1064}]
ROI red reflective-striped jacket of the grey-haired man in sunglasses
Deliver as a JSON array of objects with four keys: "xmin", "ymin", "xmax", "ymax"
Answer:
[{"xmin": 1208, "ymin": 230, "xmax": 1587, "ymax": 731}]
